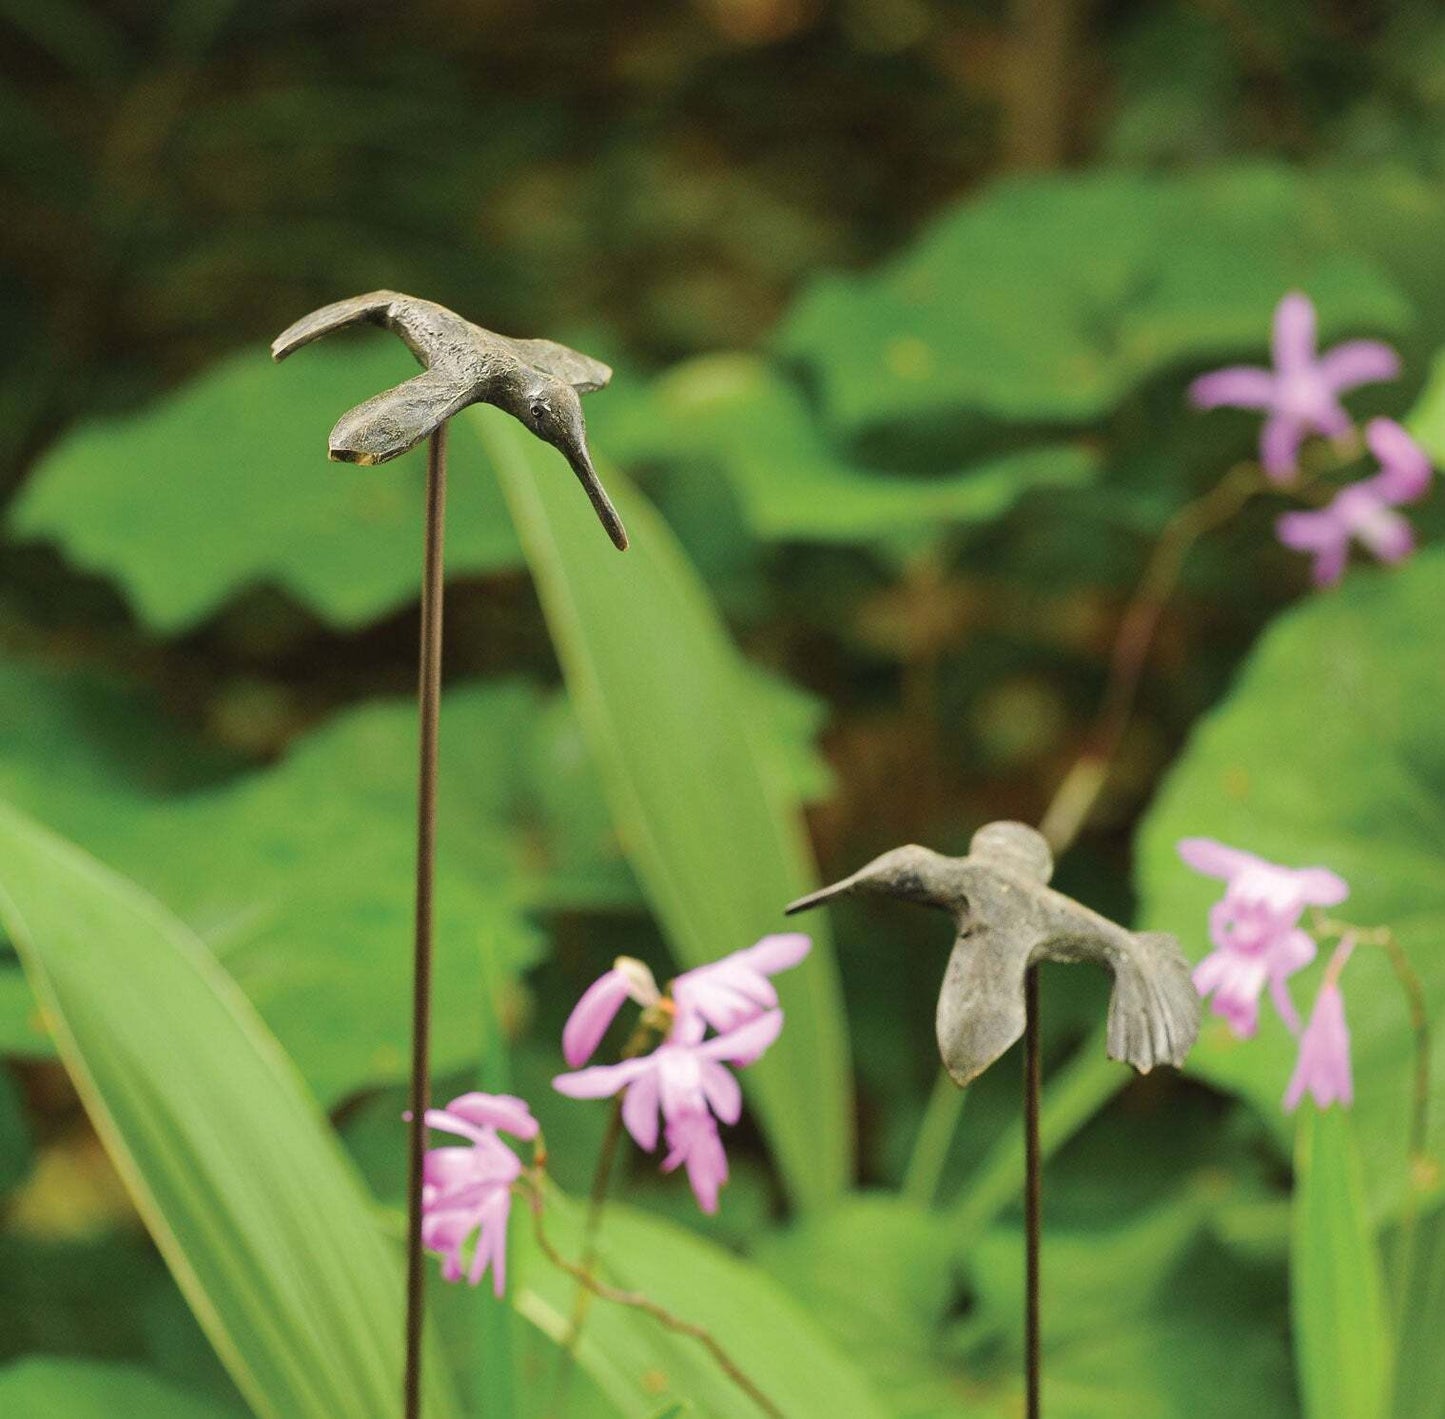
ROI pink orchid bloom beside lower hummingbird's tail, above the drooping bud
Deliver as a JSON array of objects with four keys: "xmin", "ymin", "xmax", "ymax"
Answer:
[{"xmin": 1179, "ymin": 838, "xmax": 1350, "ymax": 1039}]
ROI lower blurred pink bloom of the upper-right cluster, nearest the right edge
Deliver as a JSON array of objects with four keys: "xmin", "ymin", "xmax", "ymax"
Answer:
[{"xmin": 1274, "ymin": 419, "xmax": 1433, "ymax": 587}]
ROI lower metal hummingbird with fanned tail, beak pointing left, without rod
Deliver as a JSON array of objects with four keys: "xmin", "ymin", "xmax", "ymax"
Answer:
[{"xmin": 788, "ymin": 822, "xmax": 1199, "ymax": 1085}]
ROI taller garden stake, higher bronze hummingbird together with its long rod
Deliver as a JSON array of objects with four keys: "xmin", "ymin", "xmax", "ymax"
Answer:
[{"xmin": 272, "ymin": 290, "xmax": 627, "ymax": 1419}]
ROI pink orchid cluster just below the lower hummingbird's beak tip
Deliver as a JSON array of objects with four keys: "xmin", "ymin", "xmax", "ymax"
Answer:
[{"xmin": 553, "ymin": 933, "xmax": 811, "ymax": 1212}]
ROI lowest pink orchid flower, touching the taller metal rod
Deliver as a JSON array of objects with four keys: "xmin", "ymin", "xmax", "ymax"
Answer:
[{"xmin": 422, "ymin": 1094, "xmax": 538, "ymax": 1296}]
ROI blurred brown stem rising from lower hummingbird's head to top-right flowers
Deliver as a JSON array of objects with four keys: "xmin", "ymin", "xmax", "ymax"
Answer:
[{"xmin": 1039, "ymin": 464, "xmax": 1266, "ymax": 855}]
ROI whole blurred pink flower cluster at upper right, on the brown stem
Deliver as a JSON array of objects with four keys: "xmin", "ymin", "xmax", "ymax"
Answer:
[{"xmin": 1189, "ymin": 292, "xmax": 1432, "ymax": 587}]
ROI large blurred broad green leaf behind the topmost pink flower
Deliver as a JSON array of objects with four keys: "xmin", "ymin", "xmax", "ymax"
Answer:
[{"xmin": 779, "ymin": 168, "xmax": 1407, "ymax": 436}]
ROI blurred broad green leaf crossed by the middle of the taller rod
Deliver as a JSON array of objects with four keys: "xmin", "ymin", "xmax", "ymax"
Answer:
[{"xmin": 0, "ymin": 665, "xmax": 539, "ymax": 1104}]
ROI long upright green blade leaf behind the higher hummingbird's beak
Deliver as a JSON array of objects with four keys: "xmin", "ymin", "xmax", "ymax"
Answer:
[{"xmin": 479, "ymin": 409, "xmax": 853, "ymax": 1205}]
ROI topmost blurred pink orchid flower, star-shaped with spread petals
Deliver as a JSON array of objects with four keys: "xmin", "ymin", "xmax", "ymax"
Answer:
[{"xmin": 1189, "ymin": 290, "xmax": 1400, "ymax": 483}]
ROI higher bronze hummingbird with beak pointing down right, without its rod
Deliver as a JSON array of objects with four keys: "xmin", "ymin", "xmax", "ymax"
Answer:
[{"xmin": 272, "ymin": 290, "xmax": 627, "ymax": 551}]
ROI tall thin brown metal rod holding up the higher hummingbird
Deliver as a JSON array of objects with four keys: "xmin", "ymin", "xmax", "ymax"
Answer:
[{"xmin": 405, "ymin": 423, "xmax": 447, "ymax": 1419}]
